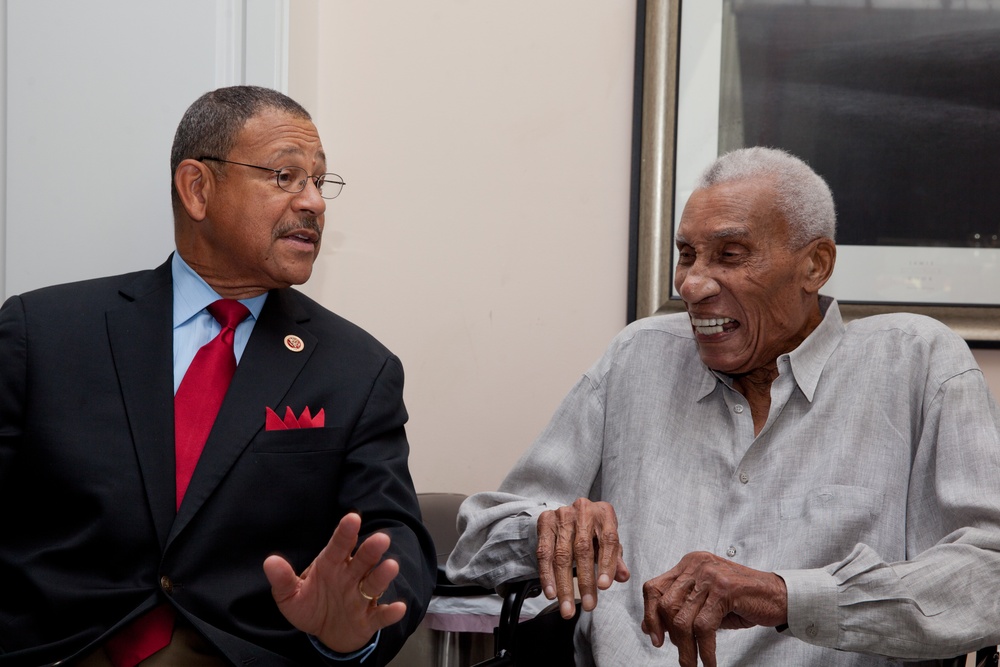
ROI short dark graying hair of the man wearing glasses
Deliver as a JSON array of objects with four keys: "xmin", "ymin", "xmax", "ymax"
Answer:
[{"xmin": 170, "ymin": 86, "xmax": 312, "ymax": 210}]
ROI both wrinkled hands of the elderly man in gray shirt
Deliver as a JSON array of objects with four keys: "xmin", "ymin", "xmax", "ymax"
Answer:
[{"xmin": 537, "ymin": 498, "xmax": 787, "ymax": 667}]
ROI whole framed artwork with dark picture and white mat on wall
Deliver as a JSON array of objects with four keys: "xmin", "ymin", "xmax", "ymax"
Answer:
[{"xmin": 632, "ymin": 0, "xmax": 1000, "ymax": 346}]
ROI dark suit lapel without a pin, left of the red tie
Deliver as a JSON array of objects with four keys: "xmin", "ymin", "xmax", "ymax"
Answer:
[{"xmin": 106, "ymin": 260, "xmax": 174, "ymax": 546}]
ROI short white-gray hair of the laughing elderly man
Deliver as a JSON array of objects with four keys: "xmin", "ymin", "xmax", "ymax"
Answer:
[{"xmin": 695, "ymin": 146, "xmax": 837, "ymax": 248}]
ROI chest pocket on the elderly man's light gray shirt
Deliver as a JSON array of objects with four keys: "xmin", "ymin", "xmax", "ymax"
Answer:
[{"xmin": 778, "ymin": 484, "xmax": 883, "ymax": 568}]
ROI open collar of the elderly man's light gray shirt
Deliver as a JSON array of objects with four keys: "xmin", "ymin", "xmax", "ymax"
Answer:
[{"xmin": 695, "ymin": 296, "xmax": 844, "ymax": 403}]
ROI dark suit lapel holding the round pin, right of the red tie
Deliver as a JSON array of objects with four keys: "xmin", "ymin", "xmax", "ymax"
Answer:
[{"xmin": 168, "ymin": 290, "xmax": 316, "ymax": 539}]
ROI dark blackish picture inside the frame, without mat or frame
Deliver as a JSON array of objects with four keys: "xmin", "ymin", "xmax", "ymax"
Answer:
[{"xmin": 720, "ymin": 0, "xmax": 1000, "ymax": 248}]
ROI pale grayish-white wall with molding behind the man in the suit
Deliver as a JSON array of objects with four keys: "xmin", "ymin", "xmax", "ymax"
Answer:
[{"xmin": 0, "ymin": 0, "xmax": 288, "ymax": 296}]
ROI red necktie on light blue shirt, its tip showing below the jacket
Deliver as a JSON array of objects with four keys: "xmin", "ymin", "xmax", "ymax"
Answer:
[{"xmin": 104, "ymin": 299, "xmax": 250, "ymax": 667}]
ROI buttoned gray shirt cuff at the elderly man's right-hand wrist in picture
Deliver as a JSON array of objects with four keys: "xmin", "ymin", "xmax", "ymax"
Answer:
[{"xmin": 775, "ymin": 569, "xmax": 840, "ymax": 648}]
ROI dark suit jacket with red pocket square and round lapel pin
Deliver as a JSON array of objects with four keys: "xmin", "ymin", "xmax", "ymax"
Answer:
[{"xmin": 0, "ymin": 261, "xmax": 436, "ymax": 667}]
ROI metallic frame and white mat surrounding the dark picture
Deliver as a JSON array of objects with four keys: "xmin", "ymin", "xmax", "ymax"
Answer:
[{"xmin": 629, "ymin": 0, "xmax": 1000, "ymax": 347}]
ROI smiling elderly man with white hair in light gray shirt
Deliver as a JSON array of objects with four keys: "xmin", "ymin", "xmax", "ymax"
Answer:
[{"xmin": 448, "ymin": 148, "xmax": 1000, "ymax": 667}]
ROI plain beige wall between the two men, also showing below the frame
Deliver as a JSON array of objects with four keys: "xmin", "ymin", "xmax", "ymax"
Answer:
[{"xmin": 289, "ymin": 0, "xmax": 1000, "ymax": 493}]
